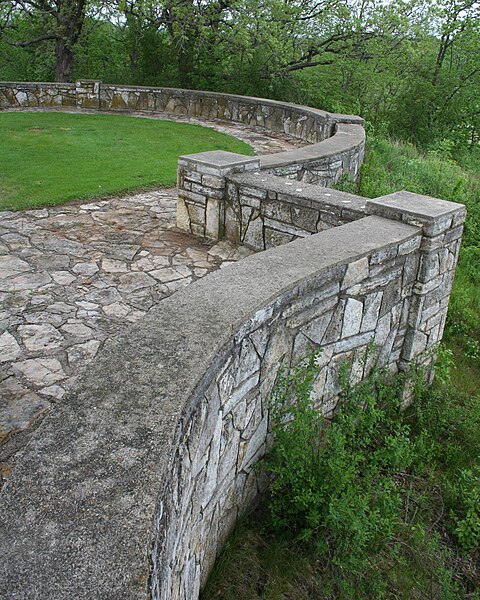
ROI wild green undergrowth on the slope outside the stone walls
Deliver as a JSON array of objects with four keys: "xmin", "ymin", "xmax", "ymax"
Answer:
[{"xmin": 202, "ymin": 136, "xmax": 480, "ymax": 600}]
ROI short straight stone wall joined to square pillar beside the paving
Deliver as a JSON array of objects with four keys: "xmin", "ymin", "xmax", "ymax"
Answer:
[{"xmin": 177, "ymin": 151, "xmax": 367, "ymax": 250}]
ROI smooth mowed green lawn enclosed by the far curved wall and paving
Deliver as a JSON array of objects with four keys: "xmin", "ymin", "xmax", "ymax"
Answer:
[{"xmin": 0, "ymin": 112, "xmax": 253, "ymax": 210}]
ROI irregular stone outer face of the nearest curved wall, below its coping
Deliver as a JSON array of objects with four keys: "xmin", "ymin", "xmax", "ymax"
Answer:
[{"xmin": 153, "ymin": 217, "xmax": 421, "ymax": 600}]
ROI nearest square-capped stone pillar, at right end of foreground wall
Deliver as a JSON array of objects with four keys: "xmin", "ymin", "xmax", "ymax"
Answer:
[{"xmin": 367, "ymin": 191, "xmax": 466, "ymax": 380}]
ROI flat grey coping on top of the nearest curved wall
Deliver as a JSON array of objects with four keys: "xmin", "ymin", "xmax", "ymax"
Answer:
[{"xmin": 0, "ymin": 216, "xmax": 418, "ymax": 600}]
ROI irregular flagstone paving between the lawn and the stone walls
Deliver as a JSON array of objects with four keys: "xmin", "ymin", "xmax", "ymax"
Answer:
[{"xmin": 0, "ymin": 113, "xmax": 303, "ymax": 485}]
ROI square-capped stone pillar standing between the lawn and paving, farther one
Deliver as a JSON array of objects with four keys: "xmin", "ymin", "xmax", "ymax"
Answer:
[{"xmin": 177, "ymin": 150, "xmax": 260, "ymax": 241}]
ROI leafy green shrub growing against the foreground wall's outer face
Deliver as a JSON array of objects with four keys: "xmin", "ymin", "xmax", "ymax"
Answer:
[{"xmin": 265, "ymin": 354, "xmax": 452, "ymax": 598}]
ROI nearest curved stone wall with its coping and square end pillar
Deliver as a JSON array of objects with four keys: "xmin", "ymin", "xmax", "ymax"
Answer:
[{"xmin": 0, "ymin": 191, "xmax": 465, "ymax": 600}]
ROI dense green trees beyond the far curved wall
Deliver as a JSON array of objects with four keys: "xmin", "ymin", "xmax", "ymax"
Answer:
[{"xmin": 0, "ymin": 0, "xmax": 480, "ymax": 153}]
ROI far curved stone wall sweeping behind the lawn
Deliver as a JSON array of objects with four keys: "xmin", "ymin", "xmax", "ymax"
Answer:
[{"xmin": 0, "ymin": 80, "xmax": 365, "ymax": 185}]
